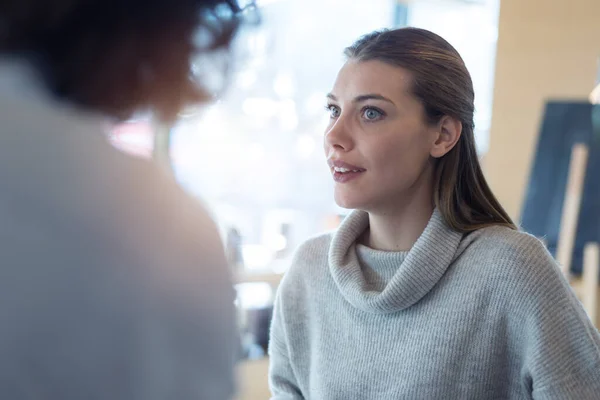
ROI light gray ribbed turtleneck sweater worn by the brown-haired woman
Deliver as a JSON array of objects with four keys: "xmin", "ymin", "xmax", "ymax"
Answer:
[{"xmin": 269, "ymin": 211, "xmax": 600, "ymax": 400}]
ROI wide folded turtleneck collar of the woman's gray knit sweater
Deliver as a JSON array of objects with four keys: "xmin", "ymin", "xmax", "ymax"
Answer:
[{"xmin": 329, "ymin": 209, "xmax": 462, "ymax": 314}]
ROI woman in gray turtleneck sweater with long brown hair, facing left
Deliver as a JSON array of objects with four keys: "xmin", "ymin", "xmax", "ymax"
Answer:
[{"xmin": 270, "ymin": 28, "xmax": 600, "ymax": 400}]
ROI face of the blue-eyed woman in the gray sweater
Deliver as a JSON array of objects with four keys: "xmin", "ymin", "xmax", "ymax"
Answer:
[{"xmin": 324, "ymin": 60, "xmax": 439, "ymax": 212}]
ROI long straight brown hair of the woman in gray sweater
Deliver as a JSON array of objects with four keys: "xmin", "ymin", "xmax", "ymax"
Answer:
[{"xmin": 344, "ymin": 28, "xmax": 517, "ymax": 232}]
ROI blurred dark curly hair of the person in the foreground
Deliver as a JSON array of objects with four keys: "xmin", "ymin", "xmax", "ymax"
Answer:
[{"xmin": 0, "ymin": 0, "xmax": 241, "ymax": 119}]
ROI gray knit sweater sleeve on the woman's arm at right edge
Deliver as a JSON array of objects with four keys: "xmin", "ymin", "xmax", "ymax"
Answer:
[{"xmin": 522, "ymin": 239, "xmax": 600, "ymax": 400}]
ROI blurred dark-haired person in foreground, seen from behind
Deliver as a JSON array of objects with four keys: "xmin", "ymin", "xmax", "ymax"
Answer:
[{"xmin": 0, "ymin": 0, "xmax": 245, "ymax": 400}]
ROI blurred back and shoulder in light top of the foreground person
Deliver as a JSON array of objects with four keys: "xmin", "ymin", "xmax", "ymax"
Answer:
[{"xmin": 0, "ymin": 1, "xmax": 244, "ymax": 400}]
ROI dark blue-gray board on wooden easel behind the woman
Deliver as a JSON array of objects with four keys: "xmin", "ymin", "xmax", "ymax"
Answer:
[{"xmin": 515, "ymin": 101, "xmax": 600, "ymax": 275}]
